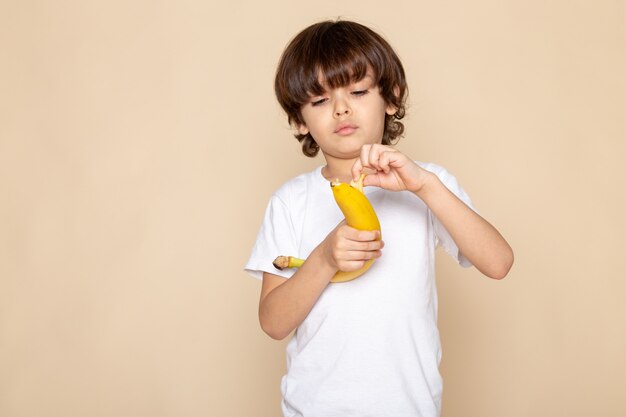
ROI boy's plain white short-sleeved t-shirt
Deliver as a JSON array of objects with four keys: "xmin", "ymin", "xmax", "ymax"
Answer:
[{"xmin": 245, "ymin": 162, "xmax": 472, "ymax": 417}]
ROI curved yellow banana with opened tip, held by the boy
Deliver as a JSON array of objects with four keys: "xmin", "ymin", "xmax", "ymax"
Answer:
[{"xmin": 274, "ymin": 174, "xmax": 380, "ymax": 282}]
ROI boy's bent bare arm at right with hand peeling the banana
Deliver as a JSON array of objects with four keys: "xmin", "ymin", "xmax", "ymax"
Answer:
[{"xmin": 352, "ymin": 144, "xmax": 513, "ymax": 279}]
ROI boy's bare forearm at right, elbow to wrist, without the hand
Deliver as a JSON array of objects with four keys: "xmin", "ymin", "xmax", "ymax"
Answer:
[{"xmin": 415, "ymin": 174, "xmax": 513, "ymax": 279}]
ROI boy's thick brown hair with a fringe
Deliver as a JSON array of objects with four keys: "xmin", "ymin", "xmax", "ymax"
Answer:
[{"xmin": 274, "ymin": 21, "xmax": 407, "ymax": 157}]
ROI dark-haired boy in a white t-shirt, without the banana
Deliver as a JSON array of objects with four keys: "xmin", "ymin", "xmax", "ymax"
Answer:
[{"xmin": 245, "ymin": 21, "xmax": 513, "ymax": 417}]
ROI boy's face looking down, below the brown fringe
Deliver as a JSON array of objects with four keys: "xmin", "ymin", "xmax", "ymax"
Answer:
[{"xmin": 297, "ymin": 73, "xmax": 396, "ymax": 159}]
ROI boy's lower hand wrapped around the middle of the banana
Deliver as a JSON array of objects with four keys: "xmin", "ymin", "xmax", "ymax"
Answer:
[{"xmin": 321, "ymin": 220, "xmax": 385, "ymax": 272}]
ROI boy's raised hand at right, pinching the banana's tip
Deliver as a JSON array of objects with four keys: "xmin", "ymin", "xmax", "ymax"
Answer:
[{"xmin": 352, "ymin": 144, "xmax": 429, "ymax": 193}]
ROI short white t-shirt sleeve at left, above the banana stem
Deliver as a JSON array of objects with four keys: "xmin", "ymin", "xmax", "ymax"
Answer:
[{"xmin": 244, "ymin": 195, "xmax": 297, "ymax": 279}]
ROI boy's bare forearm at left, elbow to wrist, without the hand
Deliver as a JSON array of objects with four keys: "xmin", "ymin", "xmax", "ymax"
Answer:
[{"xmin": 259, "ymin": 247, "xmax": 337, "ymax": 339}]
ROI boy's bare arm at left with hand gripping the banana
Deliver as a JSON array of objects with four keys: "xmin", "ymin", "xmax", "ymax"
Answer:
[{"xmin": 259, "ymin": 222, "xmax": 383, "ymax": 340}]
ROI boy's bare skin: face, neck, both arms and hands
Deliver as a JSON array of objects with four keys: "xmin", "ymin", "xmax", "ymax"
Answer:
[{"xmin": 259, "ymin": 75, "xmax": 513, "ymax": 339}]
